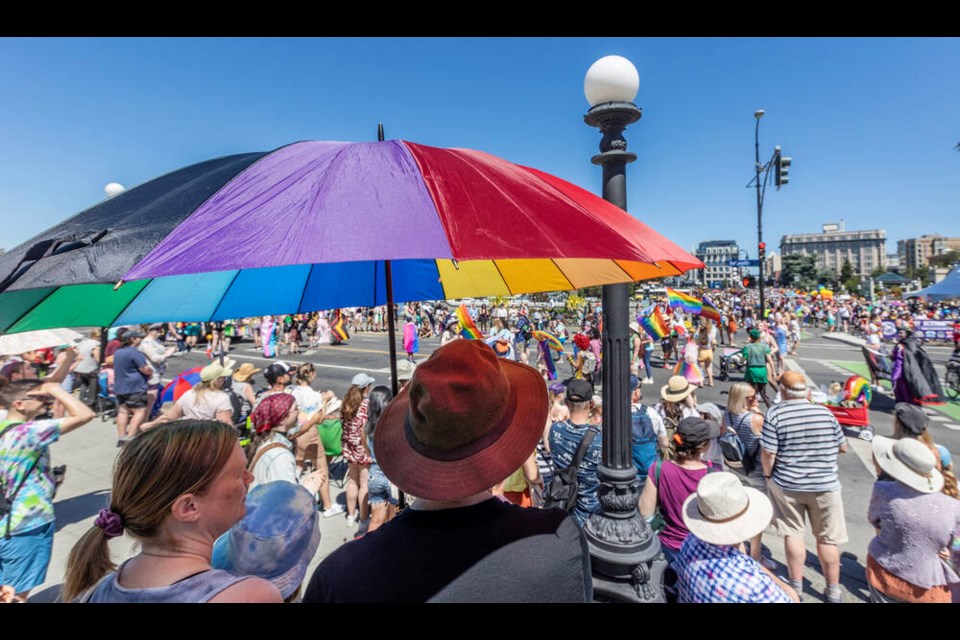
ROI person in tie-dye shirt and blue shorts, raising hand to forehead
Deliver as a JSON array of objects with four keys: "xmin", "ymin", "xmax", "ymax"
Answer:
[{"xmin": 0, "ymin": 380, "xmax": 94, "ymax": 599}]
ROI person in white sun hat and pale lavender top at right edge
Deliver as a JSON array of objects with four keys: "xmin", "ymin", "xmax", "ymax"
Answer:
[{"xmin": 867, "ymin": 436, "xmax": 960, "ymax": 602}]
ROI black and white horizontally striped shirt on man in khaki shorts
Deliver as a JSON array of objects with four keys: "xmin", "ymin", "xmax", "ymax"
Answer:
[{"xmin": 760, "ymin": 400, "xmax": 846, "ymax": 492}]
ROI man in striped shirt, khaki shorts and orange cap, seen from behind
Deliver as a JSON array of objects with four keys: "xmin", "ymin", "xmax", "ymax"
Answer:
[{"xmin": 760, "ymin": 371, "xmax": 847, "ymax": 602}]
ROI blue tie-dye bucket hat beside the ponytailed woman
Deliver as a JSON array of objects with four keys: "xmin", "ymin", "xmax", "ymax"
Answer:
[{"xmin": 211, "ymin": 480, "xmax": 320, "ymax": 599}]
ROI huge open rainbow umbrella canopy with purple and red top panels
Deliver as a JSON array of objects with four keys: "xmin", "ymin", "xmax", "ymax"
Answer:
[{"xmin": 0, "ymin": 140, "xmax": 702, "ymax": 333}]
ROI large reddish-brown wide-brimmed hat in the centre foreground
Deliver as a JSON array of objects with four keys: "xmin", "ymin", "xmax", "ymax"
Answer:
[{"xmin": 374, "ymin": 340, "xmax": 548, "ymax": 500}]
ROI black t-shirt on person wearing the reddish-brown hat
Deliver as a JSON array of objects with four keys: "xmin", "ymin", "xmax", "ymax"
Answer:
[{"xmin": 303, "ymin": 498, "xmax": 593, "ymax": 602}]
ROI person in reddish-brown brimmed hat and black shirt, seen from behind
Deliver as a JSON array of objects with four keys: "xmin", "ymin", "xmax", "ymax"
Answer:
[{"xmin": 303, "ymin": 340, "xmax": 593, "ymax": 603}]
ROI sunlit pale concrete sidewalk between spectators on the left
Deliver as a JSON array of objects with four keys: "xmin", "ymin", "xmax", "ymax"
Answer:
[{"xmin": 29, "ymin": 419, "xmax": 357, "ymax": 602}]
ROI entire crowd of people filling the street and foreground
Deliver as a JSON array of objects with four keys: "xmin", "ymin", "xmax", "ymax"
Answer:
[{"xmin": 0, "ymin": 286, "xmax": 960, "ymax": 603}]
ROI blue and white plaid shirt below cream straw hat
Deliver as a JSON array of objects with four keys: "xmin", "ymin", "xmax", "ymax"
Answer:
[{"xmin": 676, "ymin": 533, "xmax": 793, "ymax": 603}]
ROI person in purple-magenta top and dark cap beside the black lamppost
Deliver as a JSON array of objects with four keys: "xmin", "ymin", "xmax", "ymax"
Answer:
[{"xmin": 638, "ymin": 417, "xmax": 720, "ymax": 565}]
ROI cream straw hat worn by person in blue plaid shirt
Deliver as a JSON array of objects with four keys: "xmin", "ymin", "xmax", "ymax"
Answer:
[{"xmin": 683, "ymin": 471, "xmax": 773, "ymax": 545}]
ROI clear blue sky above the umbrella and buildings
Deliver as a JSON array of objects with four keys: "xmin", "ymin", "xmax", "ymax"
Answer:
[{"xmin": 0, "ymin": 38, "xmax": 960, "ymax": 256}]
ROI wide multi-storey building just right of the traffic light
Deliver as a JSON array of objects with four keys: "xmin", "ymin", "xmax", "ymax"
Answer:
[{"xmin": 780, "ymin": 219, "xmax": 887, "ymax": 277}]
